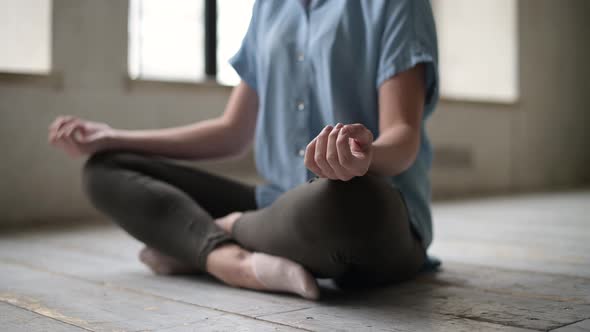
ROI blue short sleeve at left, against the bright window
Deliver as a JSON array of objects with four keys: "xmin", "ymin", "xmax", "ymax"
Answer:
[{"xmin": 229, "ymin": 1, "xmax": 259, "ymax": 90}]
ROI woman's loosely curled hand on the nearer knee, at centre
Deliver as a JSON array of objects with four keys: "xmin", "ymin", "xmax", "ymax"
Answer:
[{"xmin": 305, "ymin": 123, "xmax": 373, "ymax": 181}]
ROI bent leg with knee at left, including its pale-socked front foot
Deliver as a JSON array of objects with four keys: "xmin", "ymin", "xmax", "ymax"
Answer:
[{"xmin": 83, "ymin": 152, "xmax": 319, "ymax": 299}]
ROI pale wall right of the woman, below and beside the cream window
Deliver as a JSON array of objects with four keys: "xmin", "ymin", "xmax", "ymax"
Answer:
[{"xmin": 429, "ymin": 0, "xmax": 590, "ymax": 197}]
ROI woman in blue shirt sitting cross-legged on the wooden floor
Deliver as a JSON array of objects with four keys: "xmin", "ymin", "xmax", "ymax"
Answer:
[{"xmin": 49, "ymin": 0, "xmax": 438, "ymax": 299}]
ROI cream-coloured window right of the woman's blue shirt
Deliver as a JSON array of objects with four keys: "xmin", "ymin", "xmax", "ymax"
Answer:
[{"xmin": 432, "ymin": 0, "xmax": 518, "ymax": 103}]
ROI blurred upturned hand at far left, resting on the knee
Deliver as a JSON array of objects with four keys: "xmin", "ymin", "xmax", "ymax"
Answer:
[{"xmin": 48, "ymin": 115, "xmax": 114, "ymax": 157}]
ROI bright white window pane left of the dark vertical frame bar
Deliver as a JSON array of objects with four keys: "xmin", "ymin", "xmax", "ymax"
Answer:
[{"xmin": 129, "ymin": 0, "xmax": 205, "ymax": 82}]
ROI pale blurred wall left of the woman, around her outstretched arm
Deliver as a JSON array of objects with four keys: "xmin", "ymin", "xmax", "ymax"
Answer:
[{"xmin": 0, "ymin": 0, "xmax": 251, "ymax": 223}]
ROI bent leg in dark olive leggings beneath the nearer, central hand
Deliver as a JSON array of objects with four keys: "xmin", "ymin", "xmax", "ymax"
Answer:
[{"xmin": 226, "ymin": 174, "xmax": 426, "ymax": 288}]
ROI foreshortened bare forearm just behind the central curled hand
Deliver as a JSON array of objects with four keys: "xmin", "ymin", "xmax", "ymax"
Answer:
[{"xmin": 369, "ymin": 124, "xmax": 420, "ymax": 176}]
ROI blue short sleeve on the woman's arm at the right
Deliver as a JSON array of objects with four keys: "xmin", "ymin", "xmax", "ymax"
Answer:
[{"xmin": 376, "ymin": 0, "xmax": 438, "ymax": 104}]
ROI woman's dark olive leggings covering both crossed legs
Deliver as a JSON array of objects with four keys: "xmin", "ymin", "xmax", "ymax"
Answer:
[{"xmin": 83, "ymin": 151, "xmax": 425, "ymax": 287}]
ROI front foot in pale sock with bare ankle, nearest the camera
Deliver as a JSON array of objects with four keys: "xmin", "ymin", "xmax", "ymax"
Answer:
[{"xmin": 207, "ymin": 244, "xmax": 319, "ymax": 300}]
